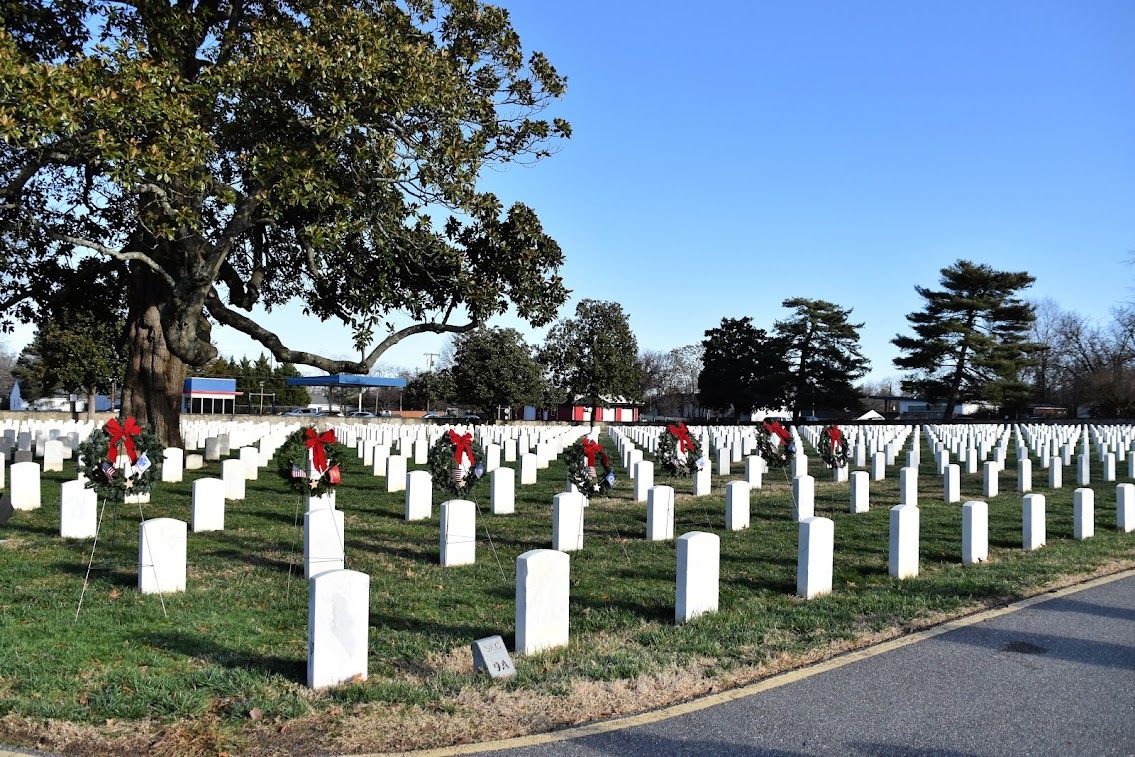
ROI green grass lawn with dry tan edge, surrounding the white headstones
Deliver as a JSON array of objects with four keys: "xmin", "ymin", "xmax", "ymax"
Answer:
[{"xmin": 0, "ymin": 429, "xmax": 1135, "ymax": 755}]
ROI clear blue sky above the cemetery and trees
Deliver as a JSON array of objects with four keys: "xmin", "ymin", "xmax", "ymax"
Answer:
[{"xmin": 14, "ymin": 0, "xmax": 1135, "ymax": 378}]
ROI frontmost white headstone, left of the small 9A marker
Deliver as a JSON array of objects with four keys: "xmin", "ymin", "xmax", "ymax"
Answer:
[{"xmin": 308, "ymin": 570, "xmax": 370, "ymax": 689}]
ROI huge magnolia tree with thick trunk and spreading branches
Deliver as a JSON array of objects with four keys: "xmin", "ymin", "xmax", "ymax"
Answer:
[{"xmin": 0, "ymin": 0, "xmax": 570, "ymax": 444}]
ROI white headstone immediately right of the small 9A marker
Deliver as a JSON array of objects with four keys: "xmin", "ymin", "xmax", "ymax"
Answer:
[{"xmin": 516, "ymin": 549, "xmax": 571, "ymax": 655}]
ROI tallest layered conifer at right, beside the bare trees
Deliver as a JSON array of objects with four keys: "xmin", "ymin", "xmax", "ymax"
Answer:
[{"xmin": 891, "ymin": 260, "xmax": 1036, "ymax": 420}]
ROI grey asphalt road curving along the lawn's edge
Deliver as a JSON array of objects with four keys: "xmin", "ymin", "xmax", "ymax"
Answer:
[{"xmin": 486, "ymin": 577, "xmax": 1135, "ymax": 757}]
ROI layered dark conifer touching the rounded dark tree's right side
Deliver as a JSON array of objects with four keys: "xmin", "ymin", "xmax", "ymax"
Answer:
[{"xmin": 774, "ymin": 297, "xmax": 871, "ymax": 421}]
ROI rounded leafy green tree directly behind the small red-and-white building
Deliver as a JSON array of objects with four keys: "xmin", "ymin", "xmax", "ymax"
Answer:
[{"xmin": 540, "ymin": 300, "xmax": 644, "ymax": 415}]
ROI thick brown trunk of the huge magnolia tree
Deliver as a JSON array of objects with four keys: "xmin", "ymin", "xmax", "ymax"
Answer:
[{"xmin": 123, "ymin": 267, "xmax": 186, "ymax": 447}]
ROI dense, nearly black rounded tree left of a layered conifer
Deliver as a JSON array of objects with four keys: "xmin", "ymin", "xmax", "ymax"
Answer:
[{"xmin": 698, "ymin": 317, "xmax": 789, "ymax": 420}]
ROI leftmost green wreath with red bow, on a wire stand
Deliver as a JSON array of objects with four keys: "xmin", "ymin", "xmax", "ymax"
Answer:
[{"xmin": 78, "ymin": 415, "xmax": 166, "ymax": 501}]
